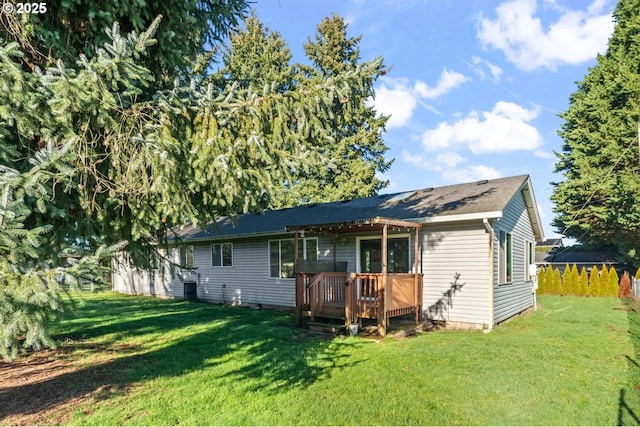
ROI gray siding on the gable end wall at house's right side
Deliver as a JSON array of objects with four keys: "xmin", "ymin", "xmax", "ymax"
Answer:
[{"xmin": 493, "ymin": 192, "xmax": 535, "ymax": 323}]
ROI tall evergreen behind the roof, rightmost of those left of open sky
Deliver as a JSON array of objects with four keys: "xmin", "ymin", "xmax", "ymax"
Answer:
[{"xmin": 264, "ymin": 14, "xmax": 391, "ymax": 207}]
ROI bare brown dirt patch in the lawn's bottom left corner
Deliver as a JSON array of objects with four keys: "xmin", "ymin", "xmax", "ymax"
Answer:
[{"xmin": 0, "ymin": 344, "xmax": 121, "ymax": 425}]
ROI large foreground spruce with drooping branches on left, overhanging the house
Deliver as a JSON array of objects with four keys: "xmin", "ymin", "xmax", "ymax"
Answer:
[{"xmin": 0, "ymin": 7, "xmax": 388, "ymax": 354}]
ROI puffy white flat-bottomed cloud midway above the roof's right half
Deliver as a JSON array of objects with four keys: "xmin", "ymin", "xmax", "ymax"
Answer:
[{"xmin": 422, "ymin": 101, "xmax": 542, "ymax": 154}]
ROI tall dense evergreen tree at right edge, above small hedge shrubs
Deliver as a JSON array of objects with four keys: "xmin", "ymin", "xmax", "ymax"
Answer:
[{"xmin": 552, "ymin": 0, "xmax": 640, "ymax": 261}]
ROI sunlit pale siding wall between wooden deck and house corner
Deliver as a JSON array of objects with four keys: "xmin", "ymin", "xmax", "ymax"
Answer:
[{"xmin": 420, "ymin": 221, "xmax": 490, "ymax": 325}]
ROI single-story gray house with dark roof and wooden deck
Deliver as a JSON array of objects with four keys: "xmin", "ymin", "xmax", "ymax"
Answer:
[{"xmin": 113, "ymin": 175, "xmax": 544, "ymax": 333}]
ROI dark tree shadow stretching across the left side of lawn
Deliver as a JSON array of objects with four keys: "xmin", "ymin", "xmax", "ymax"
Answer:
[{"xmin": 0, "ymin": 298, "xmax": 362, "ymax": 420}]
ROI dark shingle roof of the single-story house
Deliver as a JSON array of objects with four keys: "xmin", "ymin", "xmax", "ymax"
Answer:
[{"xmin": 177, "ymin": 175, "xmax": 529, "ymax": 240}]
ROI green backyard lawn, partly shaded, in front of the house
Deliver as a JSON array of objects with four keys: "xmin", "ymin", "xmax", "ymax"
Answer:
[{"xmin": 0, "ymin": 294, "xmax": 640, "ymax": 425}]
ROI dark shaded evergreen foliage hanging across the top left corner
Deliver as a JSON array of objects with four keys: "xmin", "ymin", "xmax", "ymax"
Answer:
[{"xmin": 0, "ymin": 0, "xmax": 249, "ymax": 87}]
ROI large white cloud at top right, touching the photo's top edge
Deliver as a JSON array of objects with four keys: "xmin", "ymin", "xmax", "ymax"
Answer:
[{"xmin": 477, "ymin": 0, "xmax": 613, "ymax": 71}]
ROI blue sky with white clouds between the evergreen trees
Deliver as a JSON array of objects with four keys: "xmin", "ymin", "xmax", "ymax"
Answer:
[{"xmin": 253, "ymin": 0, "xmax": 616, "ymax": 238}]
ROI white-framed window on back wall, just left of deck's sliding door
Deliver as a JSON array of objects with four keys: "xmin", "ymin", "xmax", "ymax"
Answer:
[{"xmin": 269, "ymin": 238, "xmax": 318, "ymax": 278}]
